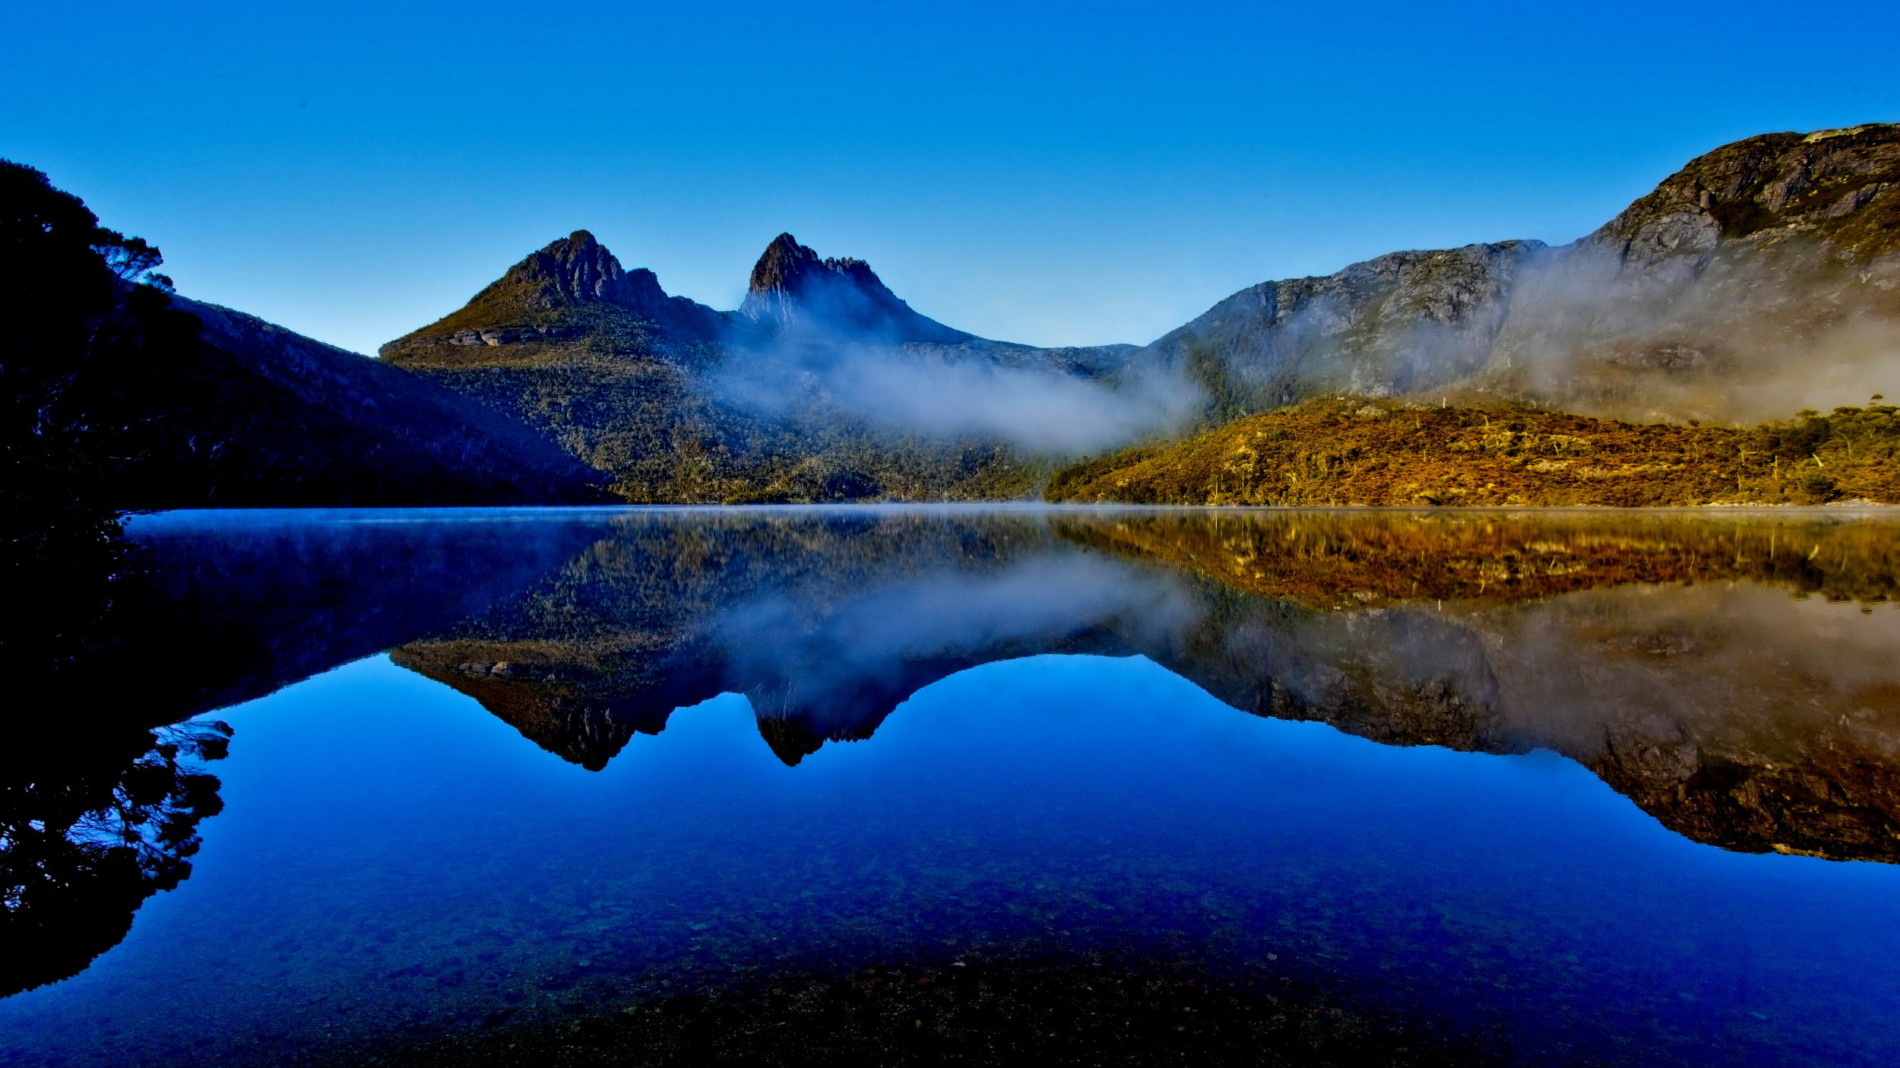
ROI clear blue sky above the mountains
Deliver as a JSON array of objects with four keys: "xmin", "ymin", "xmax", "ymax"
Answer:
[{"xmin": 11, "ymin": 0, "xmax": 1900, "ymax": 352}]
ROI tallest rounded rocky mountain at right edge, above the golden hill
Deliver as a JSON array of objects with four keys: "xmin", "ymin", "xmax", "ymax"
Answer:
[{"xmin": 1484, "ymin": 125, "xmax": 1900, "ymax": 412}]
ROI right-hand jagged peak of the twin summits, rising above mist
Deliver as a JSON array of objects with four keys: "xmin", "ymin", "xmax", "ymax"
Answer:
[{"xmin": 739, "ymin": 234, "xmax": 973, "ymax": 344}]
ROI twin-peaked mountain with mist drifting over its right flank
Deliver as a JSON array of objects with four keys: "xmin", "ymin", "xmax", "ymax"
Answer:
[{"xmin": 382, "ymin": 230, "xmax": 1159, "ymax": 502}]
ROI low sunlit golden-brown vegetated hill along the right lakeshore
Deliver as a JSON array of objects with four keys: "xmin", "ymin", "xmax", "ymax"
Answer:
[{"xmin": 1045, "ymin": 397, "xmax": 1900, "ymax": 507}]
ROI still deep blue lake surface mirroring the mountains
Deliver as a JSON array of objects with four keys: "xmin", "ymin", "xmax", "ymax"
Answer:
[{"xmin": 0, "ymin": 507, "xmax": 1900, "ymax": 1066}]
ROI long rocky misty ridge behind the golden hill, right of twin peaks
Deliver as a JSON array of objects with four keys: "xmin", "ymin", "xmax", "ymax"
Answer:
[{"xmin": 1132, "ymin": 124, "xmax": 1900, "ymax": 420}]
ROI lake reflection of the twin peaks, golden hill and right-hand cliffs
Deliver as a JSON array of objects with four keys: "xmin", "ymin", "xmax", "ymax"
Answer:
[{"xmin": 374, "ymin": 513, "xmax": 1900, "ymax": 861}]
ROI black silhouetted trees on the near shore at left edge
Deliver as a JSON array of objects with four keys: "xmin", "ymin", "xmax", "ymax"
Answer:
[{"xmin": 0, "ymin": 160, "xmax": 198, "ymax": 669}]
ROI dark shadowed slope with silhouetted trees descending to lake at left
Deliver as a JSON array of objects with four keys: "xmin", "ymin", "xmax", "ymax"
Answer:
[{"xmin": 0, "ymin": 163, "xmax": 600, "ymax": 524}]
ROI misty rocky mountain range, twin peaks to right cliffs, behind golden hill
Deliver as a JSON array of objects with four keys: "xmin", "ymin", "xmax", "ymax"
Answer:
[{"xmin": 382, "ymin": 125, "xmax": 1900, "ymax": 500}]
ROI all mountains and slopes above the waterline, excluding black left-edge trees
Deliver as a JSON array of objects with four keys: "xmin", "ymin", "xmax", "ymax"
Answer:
[{"xmin": 14, "ymin": 124, "xmax": 1900, "ymax": 507}]
